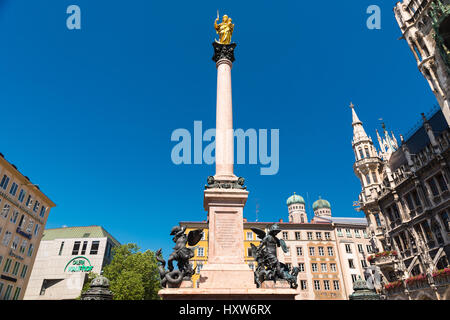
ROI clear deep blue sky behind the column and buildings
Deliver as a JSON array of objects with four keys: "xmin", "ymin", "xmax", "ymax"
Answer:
[{"xmin": 0, "ymin": 0, "xmax": 436, "ymax": 252}]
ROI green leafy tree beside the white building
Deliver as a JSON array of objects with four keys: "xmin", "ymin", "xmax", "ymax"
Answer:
[{"xmin": 103, "ymin": 243, "xmax": 161, "ymax": 300}]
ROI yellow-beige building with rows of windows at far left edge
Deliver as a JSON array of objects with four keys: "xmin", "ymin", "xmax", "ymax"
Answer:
[{"xmin": 0, "ymin": 153, "xmax": 55, "ymax": 300}]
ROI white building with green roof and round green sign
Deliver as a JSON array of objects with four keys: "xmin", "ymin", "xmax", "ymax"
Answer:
[{"xmin": 24, "ymin": 226, "xmax": 120, "ymax": 300}]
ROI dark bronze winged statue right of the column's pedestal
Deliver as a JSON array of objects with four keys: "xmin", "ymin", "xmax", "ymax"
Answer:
[{"xmin": 251, "ymin": 224, "xmax": 299, "ymax": 289}]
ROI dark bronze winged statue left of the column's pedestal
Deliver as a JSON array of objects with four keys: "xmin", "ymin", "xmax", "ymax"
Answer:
[{"xmin": 156, "ymin": 226, "xmax": 203, "ymax": 288}]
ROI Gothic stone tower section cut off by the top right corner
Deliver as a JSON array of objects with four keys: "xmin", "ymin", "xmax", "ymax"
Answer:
[{"xmin": 394, "ymin": 0, "xmax": 450, "ymax": 124}]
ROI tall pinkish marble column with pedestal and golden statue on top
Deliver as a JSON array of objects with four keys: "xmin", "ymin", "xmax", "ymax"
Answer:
[{"xmin": 200, "ymin": 16, "xmax": 256, "ymax": 289}]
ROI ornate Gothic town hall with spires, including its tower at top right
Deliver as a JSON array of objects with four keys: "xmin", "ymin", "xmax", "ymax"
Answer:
[{"xmin": 350, "ymin": 0, "xmax": 450, "ymax": 300}]
